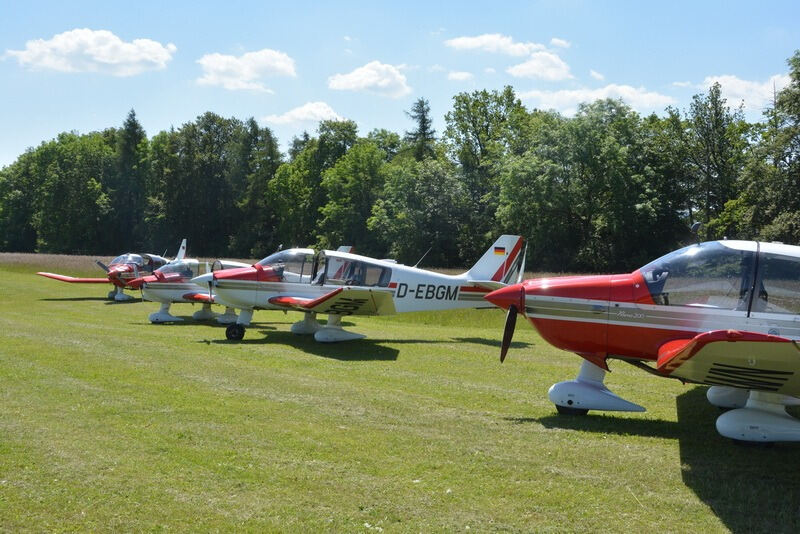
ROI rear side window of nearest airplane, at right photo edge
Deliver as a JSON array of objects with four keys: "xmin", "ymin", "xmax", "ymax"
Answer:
[{"xmin": 752, "ymin": 254, "xmax": 800, "ymax": 315}]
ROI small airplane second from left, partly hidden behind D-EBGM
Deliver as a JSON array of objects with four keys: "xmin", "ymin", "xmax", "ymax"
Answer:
[{"xmin": 128, "ymin": 246, "xmax": 353, "ymax": 324}]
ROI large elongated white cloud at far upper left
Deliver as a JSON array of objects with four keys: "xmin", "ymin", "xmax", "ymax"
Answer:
[{"xmin": 4, "ymin": 28, "xmax": 177, "ymax": 76}]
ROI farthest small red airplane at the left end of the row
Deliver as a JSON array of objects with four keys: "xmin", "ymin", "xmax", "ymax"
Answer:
[{"xmin": 36, "ymin": 239, "xmax": 186, "ymax": 301}]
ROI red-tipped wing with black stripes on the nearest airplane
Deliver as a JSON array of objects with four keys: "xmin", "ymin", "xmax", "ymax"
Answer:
[{"xmin": 657, "ymin": 330, "xmax": 800, "ymax": 396}]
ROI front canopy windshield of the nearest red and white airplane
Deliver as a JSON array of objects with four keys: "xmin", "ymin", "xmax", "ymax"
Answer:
[{"xmin": 640, "ymin": 242, "xmax": 755, "ymax": 311}]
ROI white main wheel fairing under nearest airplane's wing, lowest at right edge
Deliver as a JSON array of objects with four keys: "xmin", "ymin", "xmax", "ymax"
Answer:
[{"xmin": 717, "ymin": 391, "xmax": 800, "ymax": 443}]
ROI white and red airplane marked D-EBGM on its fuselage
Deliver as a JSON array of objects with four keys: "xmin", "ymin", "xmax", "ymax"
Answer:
[{"xmin": 192, "ymin": 235, "xmax": 524, "ymax": 343}]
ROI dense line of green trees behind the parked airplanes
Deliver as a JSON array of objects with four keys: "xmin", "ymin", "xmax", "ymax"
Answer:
[{"xmin": 0, "ymin": 51, "xmax": 800, "ymax": 271}]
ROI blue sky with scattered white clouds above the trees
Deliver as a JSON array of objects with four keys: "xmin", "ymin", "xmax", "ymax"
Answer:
[{"xmin": 0, "ymin": 0, "xmax": 800, "ymax": 165}]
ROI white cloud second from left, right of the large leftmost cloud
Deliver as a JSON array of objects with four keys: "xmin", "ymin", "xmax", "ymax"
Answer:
[{"xmin": 197, "ymin": 48, "xmax": 297, "ymax": 93}]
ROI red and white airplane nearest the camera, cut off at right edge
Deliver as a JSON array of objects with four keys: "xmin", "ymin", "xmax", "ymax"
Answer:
[{"xmin": 486, "ymin": 241, "xmax": 800, "ymax": 442}]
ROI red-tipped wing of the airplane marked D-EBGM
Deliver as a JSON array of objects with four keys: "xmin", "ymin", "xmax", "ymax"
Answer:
[{"xmin": 269, "ymin": 287, "xmax": 395, "ymax": 315}]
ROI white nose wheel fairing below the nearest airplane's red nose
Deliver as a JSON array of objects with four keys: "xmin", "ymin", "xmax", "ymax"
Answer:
[{"xmin": 547, "ymin": 360, "xmax": 645, "ymax": 415}]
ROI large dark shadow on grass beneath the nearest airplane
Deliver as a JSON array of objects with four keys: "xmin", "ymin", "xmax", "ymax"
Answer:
[{"xmin": 507, "ymin": 387, "xmax": 800, "ymax": 533}]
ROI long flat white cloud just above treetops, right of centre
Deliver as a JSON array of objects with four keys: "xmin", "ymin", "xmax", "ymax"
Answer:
[{"xmin": 519, "ymin": 84, "xmax": 677, "ymax": 114}]
